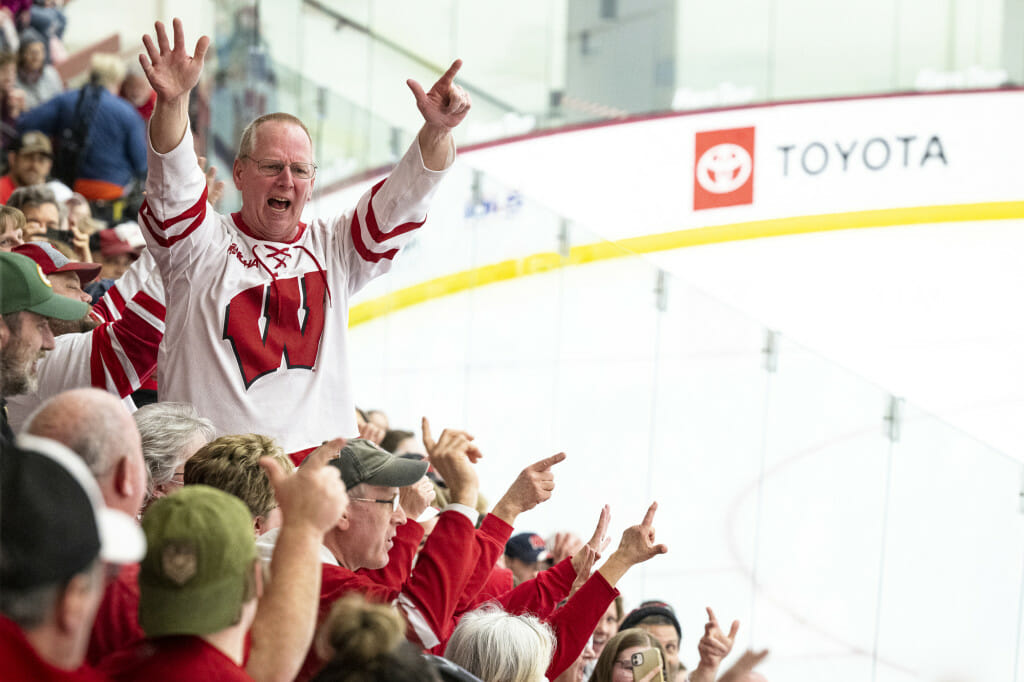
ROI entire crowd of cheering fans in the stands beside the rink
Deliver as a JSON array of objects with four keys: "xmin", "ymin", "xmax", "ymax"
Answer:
[{"xmin": 0, "ymin": 10, "xmax": 767, "ymax": 682}]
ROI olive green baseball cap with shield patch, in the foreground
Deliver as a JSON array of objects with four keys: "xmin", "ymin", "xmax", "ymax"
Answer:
[{"xmin": 138, "ymin": 484, "xmax": 257, "ymax": 637}]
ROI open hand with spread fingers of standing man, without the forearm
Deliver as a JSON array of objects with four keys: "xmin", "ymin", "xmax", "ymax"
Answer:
[{"xmin": 138, "ymin": 18, "xmax": 210, "ymax": 101}]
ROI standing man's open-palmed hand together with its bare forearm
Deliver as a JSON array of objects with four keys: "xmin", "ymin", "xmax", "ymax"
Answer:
[{"xmin": 138, "ymin": 18, "xmax": 210, "ymax": 154}]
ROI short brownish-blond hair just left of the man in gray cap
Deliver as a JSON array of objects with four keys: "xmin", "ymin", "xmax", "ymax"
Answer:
[{"xmin": 185, "ymin": 433, "xmax": 295, "ymax": 518}]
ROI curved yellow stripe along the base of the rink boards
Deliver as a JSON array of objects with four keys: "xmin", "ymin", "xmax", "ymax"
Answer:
[{"xmin": 348, "ymin": 202, "xmax": 1024, "ymax": 327}]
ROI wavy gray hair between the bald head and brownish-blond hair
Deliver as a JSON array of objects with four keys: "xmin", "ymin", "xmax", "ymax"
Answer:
[{"xmin": 132, "ymin": 402, "xmax": 217, "ymax": 499}]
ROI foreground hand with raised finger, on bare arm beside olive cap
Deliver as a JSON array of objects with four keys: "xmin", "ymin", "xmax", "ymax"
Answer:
[{"xmin": 259, "ymin": 438, "xmax": 348, "ymax": 535}]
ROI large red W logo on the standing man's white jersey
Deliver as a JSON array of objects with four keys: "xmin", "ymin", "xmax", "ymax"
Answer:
[{"xmin": 224, "ymin": 272, "xmax": 327, "ymax": 389}]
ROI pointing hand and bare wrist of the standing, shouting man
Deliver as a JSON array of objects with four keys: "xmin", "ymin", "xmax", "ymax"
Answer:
[{"xmin": 406, "ymin": 59, "xmax": 472, "ymax": 170}]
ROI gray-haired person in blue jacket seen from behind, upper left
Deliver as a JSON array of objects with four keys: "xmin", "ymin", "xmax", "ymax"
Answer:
[{"xmin": 17, "ymin": 54, "xmax": 146, "ymax": 201}]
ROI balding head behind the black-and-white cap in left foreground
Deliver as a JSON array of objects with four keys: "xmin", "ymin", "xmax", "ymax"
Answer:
[{"xmin": 25, "ymin": 388, "xmax": 146, "ymax": 516}]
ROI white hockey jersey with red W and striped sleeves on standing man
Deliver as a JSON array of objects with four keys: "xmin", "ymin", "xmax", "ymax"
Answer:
[{"xmin": 139, "ymin": 125, "xmax": 444, "ymax": 452}]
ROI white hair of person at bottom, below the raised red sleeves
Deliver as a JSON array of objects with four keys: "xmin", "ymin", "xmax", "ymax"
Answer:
[{"xmin": 444, "ymin": 604, "xmax": 555, "ymax": 682}]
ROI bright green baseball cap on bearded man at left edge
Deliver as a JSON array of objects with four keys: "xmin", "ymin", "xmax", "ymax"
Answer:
[{"xmin": 0, "ymin": 251, "xmax": 89, "ymax": 319}]
